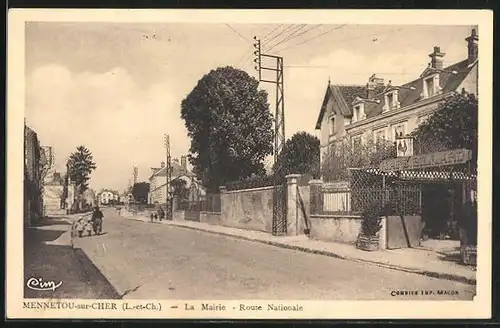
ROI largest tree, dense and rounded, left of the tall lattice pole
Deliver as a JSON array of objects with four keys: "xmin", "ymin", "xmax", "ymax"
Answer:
[{"xmin": 181, "ymin": 67, "xmax": 273, "ymax": 190}]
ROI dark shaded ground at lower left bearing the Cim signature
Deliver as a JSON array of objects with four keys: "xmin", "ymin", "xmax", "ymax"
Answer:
[{"xmin": 23, "ymin": 220, "xmax": 121, "ymax": 299}]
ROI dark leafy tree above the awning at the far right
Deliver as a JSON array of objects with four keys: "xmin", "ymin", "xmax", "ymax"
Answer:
[{"xmin": 413, "ymin": 91, "xmax": 478, "ymax": 167}]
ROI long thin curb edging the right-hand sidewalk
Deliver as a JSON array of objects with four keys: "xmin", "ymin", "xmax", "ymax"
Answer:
[{"xmin": 164, "ymin": 222, "xmax": 476, "ymax": 285}]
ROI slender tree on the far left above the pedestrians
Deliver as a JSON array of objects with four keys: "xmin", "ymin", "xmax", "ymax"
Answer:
[{"xmin": 66, "ymin": 146, "xmax": 97, "ymax": 195}]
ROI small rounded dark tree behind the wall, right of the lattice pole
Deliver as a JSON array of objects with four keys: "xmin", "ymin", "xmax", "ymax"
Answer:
[{"xmin": 279, "ymin": 132, "xmax": 320, "ymax": 178}]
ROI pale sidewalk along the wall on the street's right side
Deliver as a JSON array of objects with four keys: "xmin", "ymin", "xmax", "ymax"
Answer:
[{"xmin": 126, "ymin": 215, "xmax": 476, "ymax": 285}]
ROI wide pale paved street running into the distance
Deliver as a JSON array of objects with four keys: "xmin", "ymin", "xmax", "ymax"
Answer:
[{"xmin": 71, "ymin": 209, "xmax": 475, "ymax": 300}]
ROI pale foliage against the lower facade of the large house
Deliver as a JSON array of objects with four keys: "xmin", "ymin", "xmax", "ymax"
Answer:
[{"xmin": 321, "ymin": 138, "xmax": 396, "ymax": 182}]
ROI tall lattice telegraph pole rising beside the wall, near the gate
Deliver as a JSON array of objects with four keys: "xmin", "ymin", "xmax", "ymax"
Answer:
[{"xmin": 254, "ymin": 36, "xmax": 287, "ymax": 235}]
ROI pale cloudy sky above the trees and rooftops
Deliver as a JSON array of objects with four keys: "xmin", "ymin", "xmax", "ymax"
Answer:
[{"xmin": 25, "ymin": 22, "xmax": 472, "ymax": 190}]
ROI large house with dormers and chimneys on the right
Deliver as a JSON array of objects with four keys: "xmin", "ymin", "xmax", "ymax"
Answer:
[{"xmin": 316, "ymin": 29, "xmax": 479, "ymax": 169}]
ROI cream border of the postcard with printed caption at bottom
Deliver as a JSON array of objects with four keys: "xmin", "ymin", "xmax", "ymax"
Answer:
[{"xmin": 5, "ymin": 9, "xmax": 493, "ymax": 319}]
